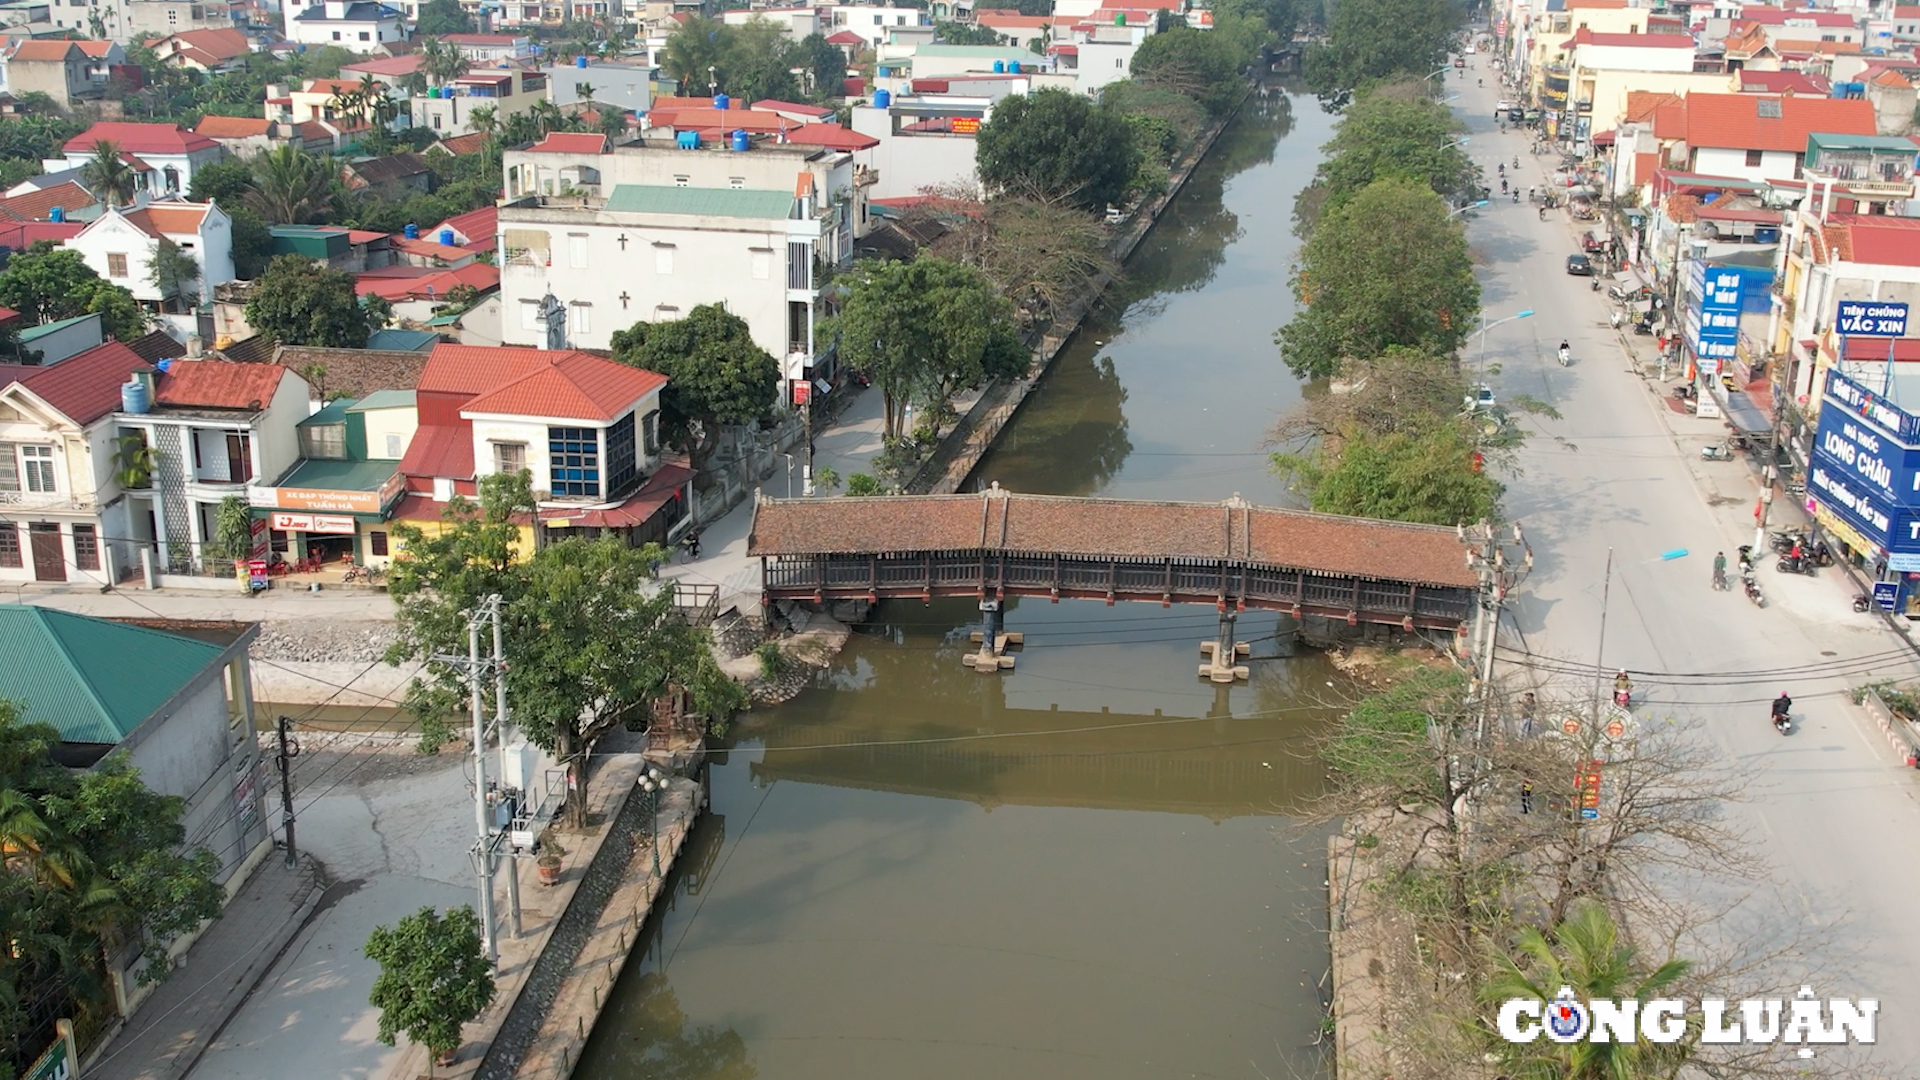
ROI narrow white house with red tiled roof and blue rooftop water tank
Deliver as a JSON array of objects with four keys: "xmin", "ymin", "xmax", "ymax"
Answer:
[{"xmin": 116, "ymin": 359, "xmax": 309, "ymax": 578}]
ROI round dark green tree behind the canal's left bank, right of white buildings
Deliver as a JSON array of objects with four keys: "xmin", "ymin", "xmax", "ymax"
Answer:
[{"xmin": 973, "ymin": 86, "xmax": 1133, "ymax": 209}]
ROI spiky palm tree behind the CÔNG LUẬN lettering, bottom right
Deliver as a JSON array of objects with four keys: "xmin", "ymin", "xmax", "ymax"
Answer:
[{"xmin": 1480, "ymin": 899, "xmax": 1697, "ymax": 1080}]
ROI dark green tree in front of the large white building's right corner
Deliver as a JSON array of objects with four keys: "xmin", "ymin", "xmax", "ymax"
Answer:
[{"xmin": 611, "ymin": 304, "xmax": 780, "ymax": 471}]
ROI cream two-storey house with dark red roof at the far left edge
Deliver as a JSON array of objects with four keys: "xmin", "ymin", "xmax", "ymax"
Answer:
[{"xmin": 0, "ymin": 342, "xmax": 152, "ymax": 584}]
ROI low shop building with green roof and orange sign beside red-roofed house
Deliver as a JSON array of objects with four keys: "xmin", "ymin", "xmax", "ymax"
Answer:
[{"xmin": 248, "ymin": 390, "xmax": 419, "ymax": 565}]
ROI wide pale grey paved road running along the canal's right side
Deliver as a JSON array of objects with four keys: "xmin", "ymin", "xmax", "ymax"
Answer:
[{"xmin": 1455, "ymin": 71, "xmax": 1920, "ymax": 1076}]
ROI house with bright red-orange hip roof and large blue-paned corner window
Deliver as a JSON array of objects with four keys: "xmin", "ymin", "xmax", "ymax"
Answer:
[{"xmin": 394, "ymin": 344, "xmax": 693, "ymax": 552}]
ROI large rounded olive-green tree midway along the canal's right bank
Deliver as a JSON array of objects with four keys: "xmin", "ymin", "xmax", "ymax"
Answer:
[{"xmin": 1275, "ymin": 179, "xmax": 1480, "ymax": 379}]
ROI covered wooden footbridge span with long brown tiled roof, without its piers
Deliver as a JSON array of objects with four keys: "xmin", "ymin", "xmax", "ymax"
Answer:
[{"xmin": 747, "ymin": 488, "xmax": 1480, "ymax": 628}]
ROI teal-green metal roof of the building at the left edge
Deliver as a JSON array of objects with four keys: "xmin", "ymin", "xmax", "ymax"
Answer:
[{"xmin": 0, "ymin": 603, "xmax": 225, "ymax": 744}]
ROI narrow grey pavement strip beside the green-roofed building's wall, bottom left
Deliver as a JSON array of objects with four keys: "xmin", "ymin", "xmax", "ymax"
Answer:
[{"xmin": 84, "ymin": 851, "xmax": 324, "ymax": 1080}]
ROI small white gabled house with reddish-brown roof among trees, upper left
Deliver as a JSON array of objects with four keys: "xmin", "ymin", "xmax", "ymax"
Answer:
[{"xmin": 67, "ymin": 202, "xmax": 234, "ymax": 307}]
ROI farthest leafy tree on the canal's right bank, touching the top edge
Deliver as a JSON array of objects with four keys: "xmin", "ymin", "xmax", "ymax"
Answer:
[{"xmin": 1302, "ymin": 0, "xmax": 1465, "ymax": 108}]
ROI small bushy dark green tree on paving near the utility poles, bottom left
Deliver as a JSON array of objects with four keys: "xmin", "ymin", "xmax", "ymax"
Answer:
[{"xmin": 363, "ymin": 905, "xmax": 493, "ymax": 1059}]
